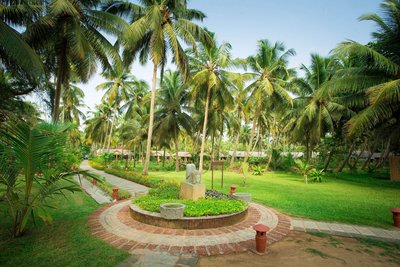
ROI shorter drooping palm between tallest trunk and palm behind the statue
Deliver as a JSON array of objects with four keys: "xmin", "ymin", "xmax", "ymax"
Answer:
[{"xmin": 154, "ymin": 71, "xmax": 194, "ymax": 171}]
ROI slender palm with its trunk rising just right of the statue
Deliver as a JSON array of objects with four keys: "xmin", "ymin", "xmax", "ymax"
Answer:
[{"xmin": 188, "ymin": 38, "xmax": 233, "ymax": 173}]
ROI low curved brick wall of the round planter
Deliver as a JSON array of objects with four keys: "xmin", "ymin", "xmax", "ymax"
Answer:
[{"xmin": 129, "ymin": 204, "xmax": 248, "ymax": 229}]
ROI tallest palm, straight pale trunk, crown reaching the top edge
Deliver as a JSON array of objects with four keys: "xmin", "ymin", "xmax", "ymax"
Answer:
[{"xmin": 107, "ymin": 0, "xmax": 212, "ymax": 175}]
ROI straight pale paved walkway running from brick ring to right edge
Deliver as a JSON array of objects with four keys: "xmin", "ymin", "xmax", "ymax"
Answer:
[{"xmin": 291, "ymin": 218, "xmax": 400, "ymax": 241}]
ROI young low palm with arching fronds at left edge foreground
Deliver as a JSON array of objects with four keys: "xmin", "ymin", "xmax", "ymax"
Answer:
[{"xmin": 0, "ymin": 122, "xmax": 79, "ymax": 237}]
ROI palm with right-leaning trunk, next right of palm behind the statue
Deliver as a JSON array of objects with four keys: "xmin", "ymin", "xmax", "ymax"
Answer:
[{"xmin": 244, "ymin": 40, "xmax": 295, "ymax": 162}]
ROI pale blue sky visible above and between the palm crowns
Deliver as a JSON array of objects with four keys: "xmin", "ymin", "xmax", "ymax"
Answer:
[{"xmin": 75, "ymin": 0, "xmax": 380, "ymax": 115}]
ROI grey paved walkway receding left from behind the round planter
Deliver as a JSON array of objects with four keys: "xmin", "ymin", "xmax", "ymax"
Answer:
[{"xmin": 80, "ymin": 160, "xmax": 149, "ymax": 196}]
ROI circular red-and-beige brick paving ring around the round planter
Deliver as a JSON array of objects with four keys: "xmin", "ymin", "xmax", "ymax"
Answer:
[{"xmin": 89, "ymin": 200, "xmax": 290, "ymax": 256}]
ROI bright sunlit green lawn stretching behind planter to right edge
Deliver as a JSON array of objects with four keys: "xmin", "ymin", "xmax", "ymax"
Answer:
[{"xmin": 150, "ymin": 171, "xmax": 400, "ymax": 228}]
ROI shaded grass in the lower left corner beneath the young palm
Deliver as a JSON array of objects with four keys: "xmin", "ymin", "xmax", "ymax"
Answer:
[{"xmin": 0, "ymin": 188, "xmax": 129, "ymax": 267}]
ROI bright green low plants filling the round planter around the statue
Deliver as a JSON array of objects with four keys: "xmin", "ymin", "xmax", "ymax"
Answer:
[{"xmin": 132, "ymin": 184, "xmax": 247, "ymax": 217}]
